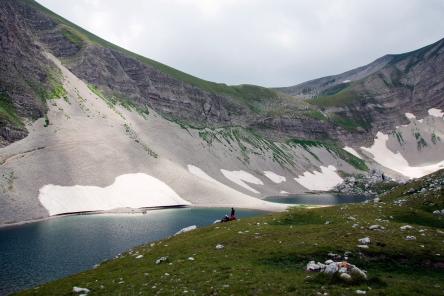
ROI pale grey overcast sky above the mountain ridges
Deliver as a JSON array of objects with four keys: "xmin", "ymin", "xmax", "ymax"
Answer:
[{"xmin": 38, "ymin": 0, "xmax": 444, "ymax": 86}]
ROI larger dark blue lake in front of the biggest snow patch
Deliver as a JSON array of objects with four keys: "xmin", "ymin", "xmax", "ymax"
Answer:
[{"xmin": 0, "ymin": 208, "xmax": 264, "ymax": 295}]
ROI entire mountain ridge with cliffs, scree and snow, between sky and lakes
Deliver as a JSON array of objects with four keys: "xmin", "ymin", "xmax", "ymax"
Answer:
[{"xmin": 0, "ymin": 0, "xmax": 444, "ymax": 224}]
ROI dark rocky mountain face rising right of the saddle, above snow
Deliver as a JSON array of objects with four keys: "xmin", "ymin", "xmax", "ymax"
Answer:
[{"xmin": 279, "ymin": 39, "xmax": 444, "ymax": 145}]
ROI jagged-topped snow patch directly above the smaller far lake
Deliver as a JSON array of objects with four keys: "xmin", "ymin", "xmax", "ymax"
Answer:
[{"xmin": 294, "ymin": 165, "xmax": 343, "ymax": 191}]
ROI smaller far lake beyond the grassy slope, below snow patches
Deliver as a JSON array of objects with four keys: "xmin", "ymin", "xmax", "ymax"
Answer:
[{"xmin": 264, "ymin": 193, "xmax": 372, "ymax": 205}]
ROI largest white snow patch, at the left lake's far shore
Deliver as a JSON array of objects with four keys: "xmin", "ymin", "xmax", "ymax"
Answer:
[{"xmin": 39, "ymin": 173, "xmax": 190, "ymax": 216}]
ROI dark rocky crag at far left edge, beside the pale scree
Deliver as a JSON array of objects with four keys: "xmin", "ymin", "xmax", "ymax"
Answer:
[{"xmin": 0, "ymin": 1, "xmax": 55, "ymax": 146}]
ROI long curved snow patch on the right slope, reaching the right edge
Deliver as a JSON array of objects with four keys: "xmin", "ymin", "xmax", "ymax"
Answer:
[{"xmin": 361, "ymin": 132, "xmax": 444, "ymax": 178}]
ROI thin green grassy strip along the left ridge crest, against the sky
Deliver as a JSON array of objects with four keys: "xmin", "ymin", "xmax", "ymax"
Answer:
[{"xmin": 20, "ymin": 0, "xmax": 281, "ymax": 104}]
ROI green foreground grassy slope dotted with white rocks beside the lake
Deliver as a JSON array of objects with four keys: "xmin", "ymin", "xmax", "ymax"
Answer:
[{"xmin": 21, "ymin": 171, "xmax": 444, "ymax": 295}]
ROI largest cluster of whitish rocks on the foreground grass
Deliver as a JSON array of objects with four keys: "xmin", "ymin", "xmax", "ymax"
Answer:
[{"xmin": 306, "ymin": 260, "xmax": 367, "ymax": 283}]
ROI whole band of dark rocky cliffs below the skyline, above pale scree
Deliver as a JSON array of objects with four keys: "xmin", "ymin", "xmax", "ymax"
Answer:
[{"xmin": 0, "ymin": 0, "xmax": 444, "ymax": 146}]
